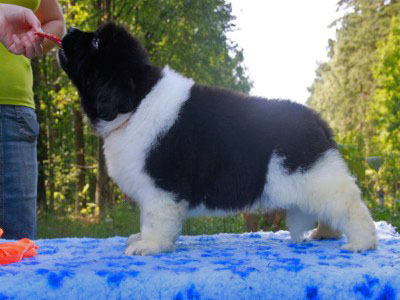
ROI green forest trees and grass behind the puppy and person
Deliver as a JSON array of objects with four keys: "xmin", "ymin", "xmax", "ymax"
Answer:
[{"xmin": 36, "ymin": 0, "xmax": 400, "ymax": 238}]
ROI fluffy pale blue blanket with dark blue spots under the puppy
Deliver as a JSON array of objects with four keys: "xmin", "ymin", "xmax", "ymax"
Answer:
[{"xmin": 0, "ymin": 222, "xmax": 400, "ymax": 300}]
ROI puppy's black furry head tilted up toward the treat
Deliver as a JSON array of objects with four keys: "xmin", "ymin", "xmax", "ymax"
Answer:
[{"xmin": 58, "ymin": 23, "xmax": 150, "ymax": 124}]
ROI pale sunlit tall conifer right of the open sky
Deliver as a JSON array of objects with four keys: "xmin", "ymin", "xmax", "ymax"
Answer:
[{"xmin": 308, "ymin": 0, "xmax": 400, "ymax": 136}]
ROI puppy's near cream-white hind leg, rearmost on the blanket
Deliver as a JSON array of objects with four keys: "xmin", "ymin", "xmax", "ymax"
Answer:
[{"xmin": 305, "ymin": 151, "xmax": 376, "ymax": 252}]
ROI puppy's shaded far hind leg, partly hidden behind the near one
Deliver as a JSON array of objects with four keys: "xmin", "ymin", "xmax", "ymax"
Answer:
[{"xmin": 286, "ymin": 207, "xmax": 315, "ymax": 243}]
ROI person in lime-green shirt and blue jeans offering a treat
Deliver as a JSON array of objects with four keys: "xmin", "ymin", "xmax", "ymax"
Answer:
[{"xmin": 0, "ymin": 0, "xmax": 65, "ymax": 239}]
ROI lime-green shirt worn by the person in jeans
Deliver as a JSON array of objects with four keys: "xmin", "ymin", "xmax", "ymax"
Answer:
[{"xmin": 0, "ymin": 0, "xmax": 40, "ymax": 108}]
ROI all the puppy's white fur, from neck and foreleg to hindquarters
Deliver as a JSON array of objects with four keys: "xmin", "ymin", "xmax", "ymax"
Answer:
[{"xmin": 100, "ymin": 67, "xmax": 376, "ymax": 255}]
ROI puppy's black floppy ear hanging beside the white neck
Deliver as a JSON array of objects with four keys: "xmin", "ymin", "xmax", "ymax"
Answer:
[{"xmin": 96, "ymin": 78, "xmax": 135, "ymax": 121}]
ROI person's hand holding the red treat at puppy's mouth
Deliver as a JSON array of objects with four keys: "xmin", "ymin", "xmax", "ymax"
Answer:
[{"xmin": 0, "ymin": 4, "xmax": 43, "ymax": 59}]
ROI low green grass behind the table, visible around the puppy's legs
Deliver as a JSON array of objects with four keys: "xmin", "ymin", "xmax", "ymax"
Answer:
[{"xmin": 37, "ymin": 202, "xmax": 400, "ymax": 239}]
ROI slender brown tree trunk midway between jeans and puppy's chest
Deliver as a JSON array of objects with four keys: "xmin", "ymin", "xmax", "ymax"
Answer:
[{"xmin": 74, "ymin": 109, "xmax": 86, "ymax": 215}]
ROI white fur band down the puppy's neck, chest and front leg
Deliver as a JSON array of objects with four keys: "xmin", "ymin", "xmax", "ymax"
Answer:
[{"xmin": 97, "ymin": 67, "xmax": 194, "ymax": 255}]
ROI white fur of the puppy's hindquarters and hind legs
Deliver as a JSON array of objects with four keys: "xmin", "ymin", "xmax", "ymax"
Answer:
[{"xmin": 261, "ymin": 150, "xmax": 376, "ymax": 251}]
